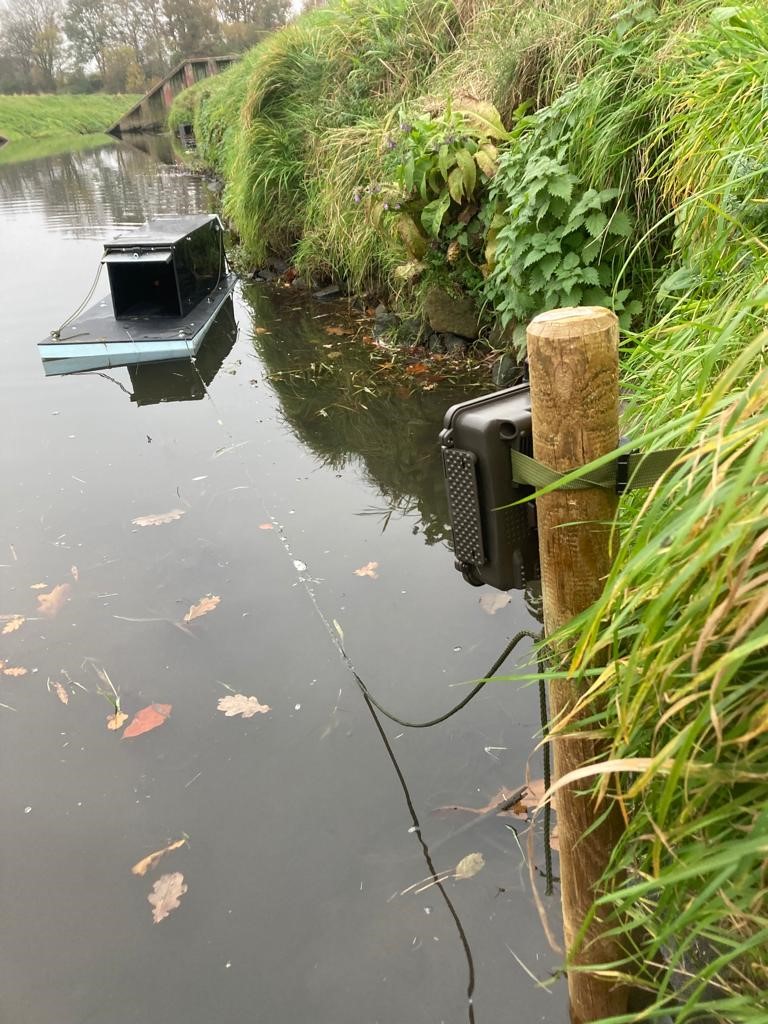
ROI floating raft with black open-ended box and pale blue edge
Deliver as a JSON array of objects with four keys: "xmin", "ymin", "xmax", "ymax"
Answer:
[{"xmin": 38, "ymin": 215, "xmax": 237, "ymax": 374}]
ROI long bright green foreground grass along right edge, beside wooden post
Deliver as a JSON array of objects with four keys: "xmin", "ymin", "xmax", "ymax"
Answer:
[{"xmin": 536, "ymin": 4, "xmax": 768, "ymax": 1024}]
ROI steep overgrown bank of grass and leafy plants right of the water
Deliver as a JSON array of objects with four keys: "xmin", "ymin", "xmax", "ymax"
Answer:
[{"xmin": 176, "ymin": 0, "xmax": 768, "ymax": 1024}]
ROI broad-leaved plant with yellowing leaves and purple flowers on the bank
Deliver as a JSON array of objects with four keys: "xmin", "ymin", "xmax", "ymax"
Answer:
[{"xmin": 364, "ymin": 101, "xmax": 508, "ymax": 288}]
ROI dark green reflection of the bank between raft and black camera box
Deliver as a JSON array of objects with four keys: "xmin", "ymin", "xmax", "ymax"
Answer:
[{"xmin": 243, "ymin": 284, "xmax": 483, "ymax": 544}]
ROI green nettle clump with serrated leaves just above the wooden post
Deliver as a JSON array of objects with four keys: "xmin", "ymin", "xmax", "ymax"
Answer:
[{"xmin": 483, "ymin": 129, "xmax": 641, "ymax": 350}]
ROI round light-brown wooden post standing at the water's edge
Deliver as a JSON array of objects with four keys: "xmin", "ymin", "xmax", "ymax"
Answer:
[{"xmin": 527, "ymin": 306, "xmax": 629, "ymax": 1024}]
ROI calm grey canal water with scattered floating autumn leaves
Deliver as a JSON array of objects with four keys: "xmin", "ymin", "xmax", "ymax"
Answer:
[{"xmin": 0, "ymin": 138, "xmax": 566, "ymax": 1024}]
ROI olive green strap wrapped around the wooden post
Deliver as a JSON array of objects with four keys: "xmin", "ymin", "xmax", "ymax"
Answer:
[{"xmin": 511, "ymin": 449, "xmax": 685, "ymax": 494}]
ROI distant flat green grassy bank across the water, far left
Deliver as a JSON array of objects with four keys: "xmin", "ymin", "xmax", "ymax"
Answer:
[{"xmin": 0, "ymin": 93, "xmax": 140, "ymax": 142}]
